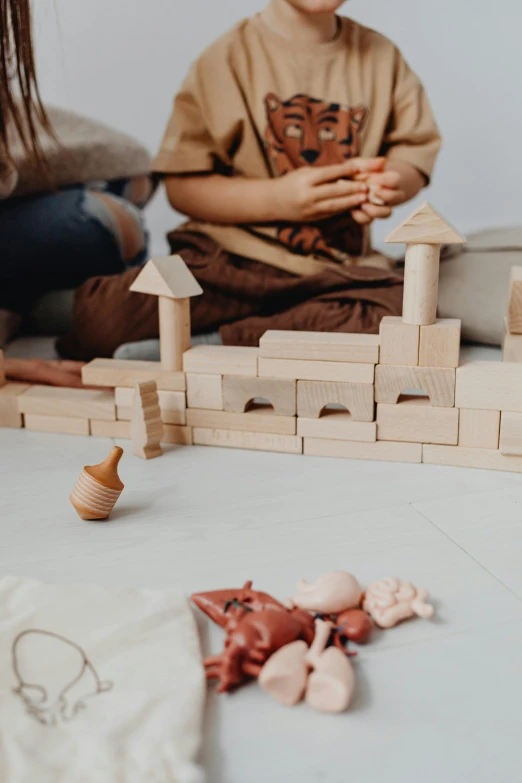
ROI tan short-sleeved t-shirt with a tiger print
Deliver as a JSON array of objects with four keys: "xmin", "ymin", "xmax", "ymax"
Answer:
[{"xmin": 154, "ymin": 16, "xmax": 440, "ymax": 274}]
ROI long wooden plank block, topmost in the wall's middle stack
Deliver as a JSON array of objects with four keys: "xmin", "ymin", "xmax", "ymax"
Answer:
[{"xmin": 259, "ymin": 330, "xmax": 380, "ymax": 364}]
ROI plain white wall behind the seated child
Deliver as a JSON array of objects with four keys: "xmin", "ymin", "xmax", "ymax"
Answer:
[{"xmin": 34, "ymin": 0, "xmax": 522, "ymax": 251}]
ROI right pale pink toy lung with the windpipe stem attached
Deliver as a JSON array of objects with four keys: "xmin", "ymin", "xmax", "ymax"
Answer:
[{"xmin": 305, "ymin": 620, "xmax": 355, "ymax": 713}]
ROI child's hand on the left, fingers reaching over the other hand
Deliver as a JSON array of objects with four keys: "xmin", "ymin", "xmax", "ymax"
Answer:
[{"xmin": 273, "ymin": 158, "xmax": 383, "ymax": 223}]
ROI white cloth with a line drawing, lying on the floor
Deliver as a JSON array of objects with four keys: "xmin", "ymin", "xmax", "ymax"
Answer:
[{"xmin": 0, "ymin": 578, "xmax": 205, "ymax": 783}]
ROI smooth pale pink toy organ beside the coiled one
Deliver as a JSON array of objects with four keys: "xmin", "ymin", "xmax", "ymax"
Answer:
[{"xmin": 291, "ymin": 571, "xmax": 362, "ymax": 614}]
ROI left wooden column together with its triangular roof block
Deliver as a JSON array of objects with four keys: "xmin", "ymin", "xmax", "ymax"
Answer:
[{"xmin": 130, "ymin": 256, "xmax": 203, "ymax": 372}]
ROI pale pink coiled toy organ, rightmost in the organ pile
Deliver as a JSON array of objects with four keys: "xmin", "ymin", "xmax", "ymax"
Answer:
[{"xmin": 363, "ymin": 577, "xmax": 434, "ymax": 628}]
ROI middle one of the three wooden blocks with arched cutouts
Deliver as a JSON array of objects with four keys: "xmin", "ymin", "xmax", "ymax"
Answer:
[{"xmin": 297, "ymin": 381, "xmax": 375, "ymax": 421}]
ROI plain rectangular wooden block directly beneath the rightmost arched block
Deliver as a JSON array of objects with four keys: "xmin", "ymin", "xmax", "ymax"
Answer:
[{"xmin": 377, "ymin": 397, "xmax": 459, "ymax": 446}]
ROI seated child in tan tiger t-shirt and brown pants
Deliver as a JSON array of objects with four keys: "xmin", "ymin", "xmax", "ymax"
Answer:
[{"xmin": 58, "ymin": 0, "xmax": 440, "ymax": 358}]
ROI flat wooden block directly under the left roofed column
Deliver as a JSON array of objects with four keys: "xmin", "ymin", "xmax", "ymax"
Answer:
[{"xmin": 82, "ymin": 359, "xmax": 185, "ymax": 391}]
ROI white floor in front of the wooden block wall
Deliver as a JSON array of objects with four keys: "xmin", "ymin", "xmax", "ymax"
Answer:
[{"xmin": 0, "ymin": 414, "xmax": 522, "ymax": 783}]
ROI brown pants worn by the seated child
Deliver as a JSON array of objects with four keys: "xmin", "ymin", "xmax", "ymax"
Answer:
[{"xmin": 58, "ymin": 231, "xmax": 402, "ymax": 360}]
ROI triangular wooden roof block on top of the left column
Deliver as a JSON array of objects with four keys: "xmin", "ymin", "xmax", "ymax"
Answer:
[{"xmin": 130, "ymin": 256, "xmax": 203, "ymax": 299}]
